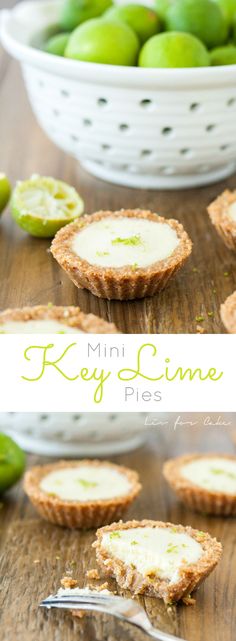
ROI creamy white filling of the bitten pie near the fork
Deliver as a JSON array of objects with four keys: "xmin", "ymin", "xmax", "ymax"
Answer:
[{"xmin": 102, "ymin": 526, "xmax": 203, "ymax": 583}]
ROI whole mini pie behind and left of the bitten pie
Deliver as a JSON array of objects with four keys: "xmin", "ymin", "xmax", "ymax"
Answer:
[{"xmin": 24, "ymin": 460, "xmax": 141, "ymax": 529}]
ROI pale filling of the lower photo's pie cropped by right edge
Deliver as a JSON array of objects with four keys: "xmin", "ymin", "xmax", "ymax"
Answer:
[{"xmin": 181, "ymin": 457, "xmax": 236, "ymax": 494}]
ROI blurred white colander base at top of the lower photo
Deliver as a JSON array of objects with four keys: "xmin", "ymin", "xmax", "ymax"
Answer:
[{"xmin": 0, "ymin": 412, "xmax": 148, "ymax": 457}]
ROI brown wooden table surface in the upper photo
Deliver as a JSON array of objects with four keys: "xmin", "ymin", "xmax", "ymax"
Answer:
[{"xmin": 0, "ymin": 8, "xmax": 236, "ymax": 333}]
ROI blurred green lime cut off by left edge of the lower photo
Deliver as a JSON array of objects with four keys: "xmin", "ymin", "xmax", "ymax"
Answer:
[{"xmin": 0, "ymin": 433, "xmax": 25, "ymax": 494}]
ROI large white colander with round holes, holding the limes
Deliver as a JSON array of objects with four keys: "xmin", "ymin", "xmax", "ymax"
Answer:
[{"xmin": 1, "ymin": 0, "xmax": 236, "ymax": 189}]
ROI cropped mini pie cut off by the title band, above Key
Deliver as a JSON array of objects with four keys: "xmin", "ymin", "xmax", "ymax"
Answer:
[{"xmin": 0, "ymin": 305, "xmax": 118, "ymax": 334}]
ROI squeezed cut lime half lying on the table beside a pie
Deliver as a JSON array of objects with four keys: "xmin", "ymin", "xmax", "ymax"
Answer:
[{"xmin": 11, "ymin": 175, "xmax": 84, "ymax": 238}]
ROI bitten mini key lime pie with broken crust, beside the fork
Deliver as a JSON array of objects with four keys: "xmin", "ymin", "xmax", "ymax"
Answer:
[{"xmin": 93, "ymin": 520, "xmax": 222, "ymax": 603}]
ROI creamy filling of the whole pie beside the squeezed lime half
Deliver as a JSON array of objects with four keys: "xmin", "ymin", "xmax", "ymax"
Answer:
[{"xmin": 72, "ymin": 217, "xmax": 179, "ymax": 269}]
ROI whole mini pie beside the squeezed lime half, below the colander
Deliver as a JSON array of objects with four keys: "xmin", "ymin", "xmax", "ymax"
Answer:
[{"xmin": 51, "ymin": 209, "xmax": 192, "ymax": 300}]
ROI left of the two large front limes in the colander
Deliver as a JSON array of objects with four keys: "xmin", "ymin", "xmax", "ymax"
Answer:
[{"xmin": 65, "ymin": 19, "xmax": 139, "ymax": 66}]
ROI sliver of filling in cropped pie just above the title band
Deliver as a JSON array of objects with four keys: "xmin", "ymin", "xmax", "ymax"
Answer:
[{"xmin": 0, "ymin": 318, "xmax": 85, "ymax": 334}]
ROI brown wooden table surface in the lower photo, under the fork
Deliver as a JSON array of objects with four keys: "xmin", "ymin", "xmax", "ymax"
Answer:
[{"xmin": 0, "ymin": 416, "xmax": 236, "ymax": 641}]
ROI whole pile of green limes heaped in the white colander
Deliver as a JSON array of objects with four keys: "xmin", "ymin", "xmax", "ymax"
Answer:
[{"xmin": 39, "ymin": 0, "xmax": 236, "ymax": 68}]
